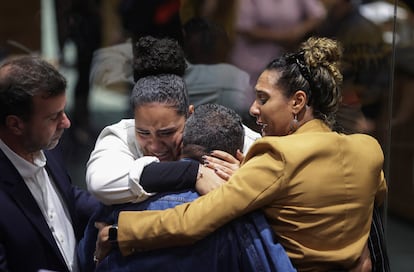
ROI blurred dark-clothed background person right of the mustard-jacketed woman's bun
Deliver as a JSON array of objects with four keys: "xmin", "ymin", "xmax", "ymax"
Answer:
[{"xmin": 318, "ymin": 0, "xmax": 391, "ymax": 138}]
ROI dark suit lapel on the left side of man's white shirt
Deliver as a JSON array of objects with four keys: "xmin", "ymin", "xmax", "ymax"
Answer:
[{"xmin": 0, "ymin": 150, "xmax": 65, "ymax": 263}]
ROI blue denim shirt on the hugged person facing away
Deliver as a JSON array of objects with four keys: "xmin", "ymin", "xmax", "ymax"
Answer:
[{"xmin": 78, "ymin": 191, "xmax": 296, "ymax": 272}]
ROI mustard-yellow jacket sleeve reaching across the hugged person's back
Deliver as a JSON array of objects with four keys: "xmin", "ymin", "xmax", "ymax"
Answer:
[{"xmin": 118, "ymin": 149, "xmax": 283, "ymax": 255}]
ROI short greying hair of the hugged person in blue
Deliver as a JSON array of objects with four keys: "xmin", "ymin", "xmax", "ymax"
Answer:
[{"xmin": 183, "ymin": 104, "xmax": 244, "ymax": 160}]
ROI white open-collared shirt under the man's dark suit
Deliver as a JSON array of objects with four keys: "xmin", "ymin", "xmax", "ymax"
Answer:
[{"xmin": 0, "ymin": 139, "xmax": 79, "ymax": 271}]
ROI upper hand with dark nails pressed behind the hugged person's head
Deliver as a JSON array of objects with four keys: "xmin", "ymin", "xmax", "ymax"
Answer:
[{"xmin": 203, "ymin": 150, "xmax": 244, "ymax": 181}]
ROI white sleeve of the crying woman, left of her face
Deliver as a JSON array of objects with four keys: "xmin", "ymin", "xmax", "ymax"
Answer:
[{"xmin": 86, "ymin": 120, "xmax": 159, "ymax": 205}]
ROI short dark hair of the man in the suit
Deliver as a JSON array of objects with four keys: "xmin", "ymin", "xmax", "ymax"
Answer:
[{"xmin": 0, "ymin": 56, "xmax": 66, "ymax": 125}]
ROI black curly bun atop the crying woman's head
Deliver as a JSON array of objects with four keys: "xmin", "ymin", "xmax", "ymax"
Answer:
[{"xmin": 133, "ymin": 36, "xmax": 187, "ymax": 81}]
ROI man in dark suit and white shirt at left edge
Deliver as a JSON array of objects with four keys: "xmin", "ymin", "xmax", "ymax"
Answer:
[{"xmin": 0, "ymin": 56, "xmax": 97, "ymax": 272}]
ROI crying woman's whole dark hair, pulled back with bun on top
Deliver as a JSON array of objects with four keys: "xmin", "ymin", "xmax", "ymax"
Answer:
[{"xmin": 130, "ymin": 36, "xmax": 190, "ymax": 117}]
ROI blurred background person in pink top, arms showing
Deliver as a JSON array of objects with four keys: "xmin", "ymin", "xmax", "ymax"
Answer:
[{"xmin": 230, "ymin": 0, "xmax": 326, "ymax": 84}]
